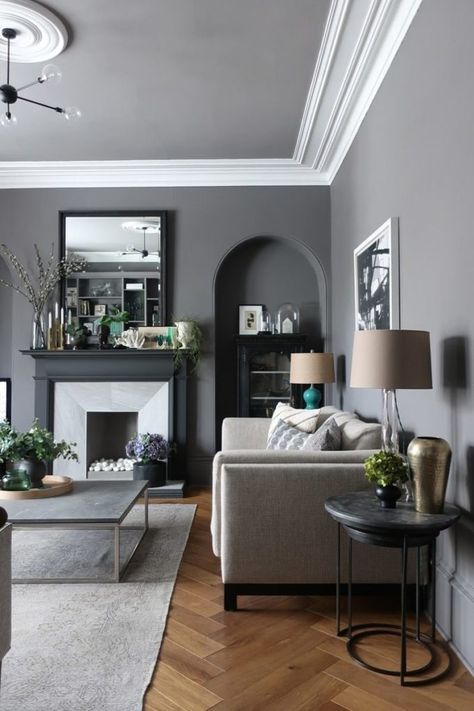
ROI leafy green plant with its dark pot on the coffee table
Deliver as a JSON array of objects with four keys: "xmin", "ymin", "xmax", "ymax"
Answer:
[{"xmin": 0, "ymin": 419, "xmax": 78, "ymax": 489}]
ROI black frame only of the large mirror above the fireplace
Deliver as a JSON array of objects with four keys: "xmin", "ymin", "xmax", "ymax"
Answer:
[{"xmin": 59, "ymin": 209, "xmax": 168, "ymax": 326}]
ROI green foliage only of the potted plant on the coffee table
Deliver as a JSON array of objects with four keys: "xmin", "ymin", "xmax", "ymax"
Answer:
[{"xmin": 4, "ymin": 419, "xmax": 78, "ymax": 462}]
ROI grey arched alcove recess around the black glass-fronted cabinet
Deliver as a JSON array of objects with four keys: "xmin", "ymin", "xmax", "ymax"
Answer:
[{"xmin": 214, "ymin": 235, "xmax": 327, "ymax": 448}]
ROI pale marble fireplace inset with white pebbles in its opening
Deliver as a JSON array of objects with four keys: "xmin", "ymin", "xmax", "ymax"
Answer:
[{"xmin": 54, "ymin": 381, "xmax": 169, "ymax": 479}]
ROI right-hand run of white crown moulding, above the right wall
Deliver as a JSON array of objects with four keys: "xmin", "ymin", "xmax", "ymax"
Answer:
[{"xmin": 297, "ymin": 0, "xmax": 422, "ymax": 183}]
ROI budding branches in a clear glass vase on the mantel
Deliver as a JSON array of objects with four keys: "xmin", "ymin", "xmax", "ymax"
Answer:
[{"xmin": 0, "ymin": 243, "xmax": 86, "ymax": 350}]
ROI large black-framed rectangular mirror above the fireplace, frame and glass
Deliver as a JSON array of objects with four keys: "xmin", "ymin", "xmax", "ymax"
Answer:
[{"xmin": 60, "ymin": 210, "xmax": 167, "ymax": 333}]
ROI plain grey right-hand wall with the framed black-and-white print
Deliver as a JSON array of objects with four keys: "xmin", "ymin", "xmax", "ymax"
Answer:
[{"xmin": 331, "ymin": 0, "xmax": 474, "ymax": 668}]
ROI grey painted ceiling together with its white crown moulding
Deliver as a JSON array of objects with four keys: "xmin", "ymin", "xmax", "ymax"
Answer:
[{"xmin": 0, "ymin": 0, "xmax": 421, "ymax": 188}]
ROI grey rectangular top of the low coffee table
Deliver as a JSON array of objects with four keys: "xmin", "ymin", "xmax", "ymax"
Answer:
[{"xmin": 2, "ymin": 479, "xmax": 148, "ymax": 525}]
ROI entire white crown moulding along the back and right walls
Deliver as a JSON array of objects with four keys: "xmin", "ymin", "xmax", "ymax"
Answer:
[{"xmin": 0, "ymin": 0, "xmax": 422, "ymax": 189}]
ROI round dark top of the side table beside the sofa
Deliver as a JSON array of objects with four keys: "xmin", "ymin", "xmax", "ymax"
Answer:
[{"xmin": 325, "ymin": 491, "xmax": 461, "ymax": 535}]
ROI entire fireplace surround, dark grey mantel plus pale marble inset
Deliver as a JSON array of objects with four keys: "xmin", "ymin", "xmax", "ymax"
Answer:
[{"xmin": 22, "ymin": 349, "xmax": 187, "ymax": 490}]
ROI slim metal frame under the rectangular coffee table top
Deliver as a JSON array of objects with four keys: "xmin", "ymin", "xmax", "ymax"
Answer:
[{"xmin": 12, "ymin": 488, "xmax": 148, "ymax": 583}]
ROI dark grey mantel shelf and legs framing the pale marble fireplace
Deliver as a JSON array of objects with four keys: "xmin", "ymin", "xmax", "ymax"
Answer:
[{"xmin": 21, "ymin": 348, "xmax": 188, "ymax": 480}]
